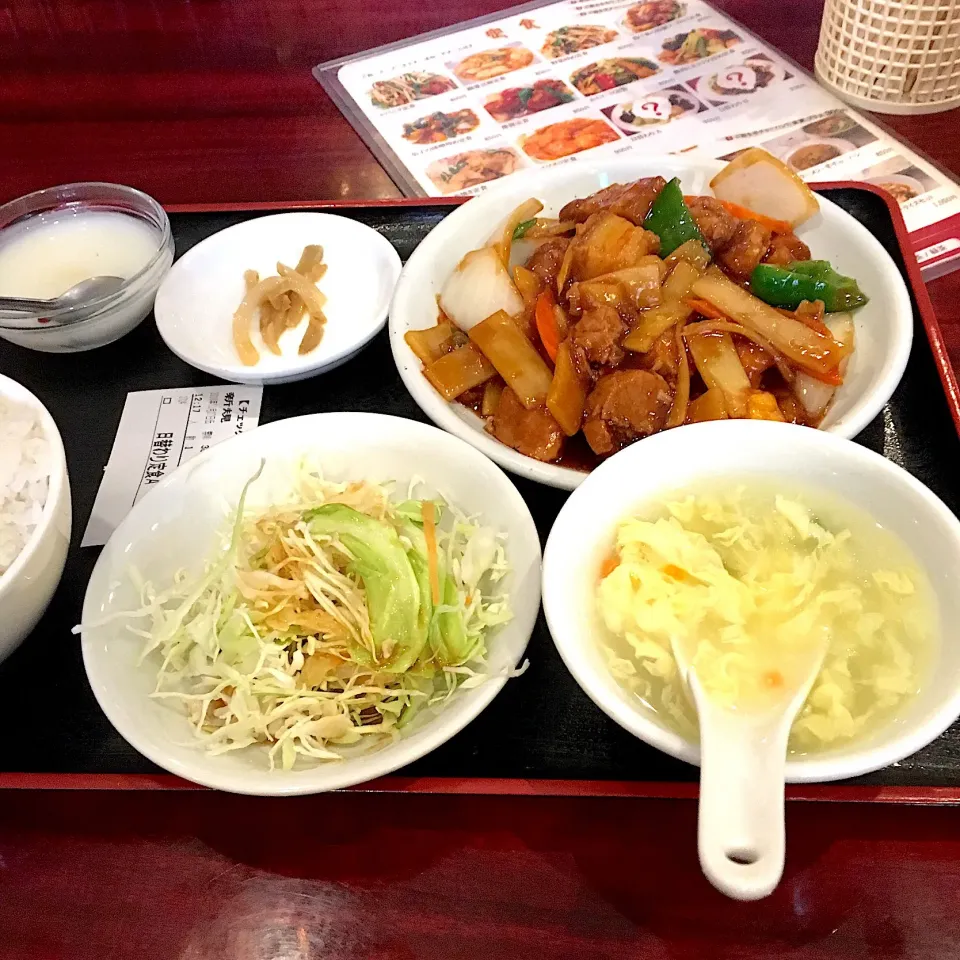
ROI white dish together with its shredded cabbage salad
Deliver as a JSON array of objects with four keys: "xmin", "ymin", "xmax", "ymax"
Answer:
[{"xmin": 79, "ymin": 413, "xmax": 540, "ymax": 795}]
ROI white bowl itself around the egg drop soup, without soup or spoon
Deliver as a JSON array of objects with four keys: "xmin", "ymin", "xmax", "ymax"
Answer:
[{"xmin": 543, "ymin": 421, "xmax": 960, "ymax": 783}]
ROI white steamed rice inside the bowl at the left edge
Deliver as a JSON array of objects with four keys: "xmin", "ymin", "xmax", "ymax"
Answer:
[{"xmin": 0, "ymin": 397, "xmax": 50, "ymax": 577}]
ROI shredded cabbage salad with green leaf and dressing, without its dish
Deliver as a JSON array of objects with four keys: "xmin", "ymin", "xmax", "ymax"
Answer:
[{"xmin": 94, "ymin": 464, "xmax": 522, "ymax": 769}]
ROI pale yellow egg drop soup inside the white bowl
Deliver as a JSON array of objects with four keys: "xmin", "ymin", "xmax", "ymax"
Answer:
[{"xmin": 597, "ymin": 485, "xmax": 936, "ymax": 752}]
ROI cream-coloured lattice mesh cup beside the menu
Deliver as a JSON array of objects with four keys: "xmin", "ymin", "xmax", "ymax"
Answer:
[{"xmin": 816, "ymin": 0, "xmax": 960, "ymax": 113}]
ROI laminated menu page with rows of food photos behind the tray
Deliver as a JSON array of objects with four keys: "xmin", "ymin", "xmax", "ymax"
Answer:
[{"xmin": 314, "ymin": 0, "xmax": 960, "ymax": 275}]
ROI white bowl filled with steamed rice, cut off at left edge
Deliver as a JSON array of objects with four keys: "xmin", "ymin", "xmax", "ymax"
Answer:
[{"xmin": 0, "ymin": 376, "xmax": 72, "ymax": 660}]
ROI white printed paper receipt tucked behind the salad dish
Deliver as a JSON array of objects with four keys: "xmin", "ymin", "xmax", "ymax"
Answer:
[{"xmin": 80, "ymin": 384, "xmax": 263, "ymax": 547}]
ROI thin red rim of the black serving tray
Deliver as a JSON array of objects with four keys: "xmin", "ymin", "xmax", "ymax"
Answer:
[{"xmin": 43, "ymin": 180, "xmax": 960, "ymax": 805}]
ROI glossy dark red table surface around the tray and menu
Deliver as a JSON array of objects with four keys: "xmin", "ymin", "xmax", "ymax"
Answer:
[{"xmin": 0, "ymin": 0, "xmax": 960, "ymax": 960}]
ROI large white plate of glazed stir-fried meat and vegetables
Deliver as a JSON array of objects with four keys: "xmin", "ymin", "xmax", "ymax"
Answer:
[{"xmin": 390, "ymin": 156, "xmax": 913, "ymax": 489}]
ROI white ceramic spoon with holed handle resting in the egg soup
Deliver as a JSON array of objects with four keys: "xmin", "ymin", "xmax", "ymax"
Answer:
[{"xmin": 673, "ymin": 642, "xmax": 826, "ymax": 900}]
